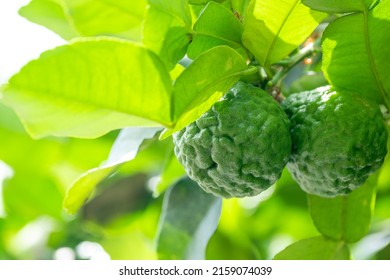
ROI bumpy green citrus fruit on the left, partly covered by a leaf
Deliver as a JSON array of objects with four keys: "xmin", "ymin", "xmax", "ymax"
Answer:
[{"xmin": 173, "ymin": 82, "xmax": 291, "ymax": 198}]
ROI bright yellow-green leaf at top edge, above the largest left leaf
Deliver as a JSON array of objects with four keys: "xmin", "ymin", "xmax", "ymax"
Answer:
[{"xmin": 20, "ymin": 0, "xmax": 147, "ymax": 41}]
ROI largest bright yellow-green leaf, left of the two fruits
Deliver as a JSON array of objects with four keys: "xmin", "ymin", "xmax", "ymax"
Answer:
[{"xmin": 3, "ymin": 38, "xmax": 172, "ymax": 138}]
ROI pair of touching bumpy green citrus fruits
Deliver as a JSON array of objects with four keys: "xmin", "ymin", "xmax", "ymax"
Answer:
[{"xmin": 173, "ymin": 82, "xmax": 387, "ymax": 198}]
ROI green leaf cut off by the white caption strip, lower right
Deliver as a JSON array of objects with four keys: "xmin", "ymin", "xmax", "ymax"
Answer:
[{"xmin": 274, "ymin": 236, "xmax": 351, "ymax": 260}]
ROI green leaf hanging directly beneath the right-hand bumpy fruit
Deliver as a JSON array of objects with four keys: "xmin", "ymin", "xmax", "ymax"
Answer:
[{"xmin": 308, "ymin": 176, "xmax": 377, "ymax": 243}]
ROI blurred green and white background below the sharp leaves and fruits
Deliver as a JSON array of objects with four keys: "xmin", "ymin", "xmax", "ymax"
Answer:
[{"xmin": 0, "ymin": 97, "xmax": 390, "ymax": 259}]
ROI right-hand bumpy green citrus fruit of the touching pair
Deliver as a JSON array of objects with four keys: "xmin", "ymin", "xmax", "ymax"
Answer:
[{"xmin": 282, "ymin": 87, "xmax": 387, "ymax": 197}]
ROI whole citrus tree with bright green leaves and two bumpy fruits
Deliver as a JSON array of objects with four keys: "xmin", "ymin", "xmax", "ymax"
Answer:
[{"xmin": 0, "ymin": 0, "xmax": 390, "ymax": 259}]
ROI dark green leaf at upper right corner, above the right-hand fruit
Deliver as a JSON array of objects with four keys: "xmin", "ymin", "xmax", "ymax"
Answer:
[{"xmin": 322, "ymin": 1, "xmax": 390, "ymax": 107}]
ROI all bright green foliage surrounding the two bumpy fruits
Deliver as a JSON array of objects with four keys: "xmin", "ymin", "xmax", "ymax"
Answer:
[{"xmin": 0, "ymin": 0, "xmax": 390, "ymax": 259}]
